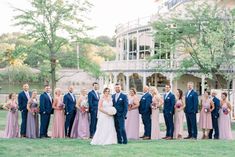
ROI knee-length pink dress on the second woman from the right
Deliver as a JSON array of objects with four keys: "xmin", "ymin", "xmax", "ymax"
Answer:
[{"xmin": 199, "ymin": 99, "xmax": 212, "ymax": 129}]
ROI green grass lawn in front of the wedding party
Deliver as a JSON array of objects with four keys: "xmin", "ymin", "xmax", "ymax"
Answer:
[{"xmin": 0, "ymin": 111, "xmax": 235, "ymax": 157}]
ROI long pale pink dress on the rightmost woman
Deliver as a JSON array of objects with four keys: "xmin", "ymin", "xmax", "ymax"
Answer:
[{"xmin": 218, "ymin": 103, "xmax": 233, "ymax": 140}]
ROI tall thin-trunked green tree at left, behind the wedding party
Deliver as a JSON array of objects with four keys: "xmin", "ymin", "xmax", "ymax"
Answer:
[{"xmin": 15, "ymin": 0, "xmax": 92, "ymax": 92}]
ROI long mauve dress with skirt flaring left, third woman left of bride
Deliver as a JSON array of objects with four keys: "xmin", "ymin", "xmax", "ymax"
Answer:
[{"xmin": 71, "ymin": 96, "xmax": 90, "ymax": 139}]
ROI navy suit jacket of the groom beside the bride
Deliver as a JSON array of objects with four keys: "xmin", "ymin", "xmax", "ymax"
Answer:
[{"xmin": 112, "ymin": 93, "xmax": 128, "ymax": 118}]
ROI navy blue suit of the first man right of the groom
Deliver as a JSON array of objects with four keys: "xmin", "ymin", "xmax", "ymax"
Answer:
[{"xmin": 139, "ymin": 93, "xmax": 152, "ymax": 137}]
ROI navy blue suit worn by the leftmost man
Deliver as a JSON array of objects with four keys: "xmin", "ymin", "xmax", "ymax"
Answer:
[{"xmin": 18, "ymin": 91, "xmax": 31, "ymax": 135}]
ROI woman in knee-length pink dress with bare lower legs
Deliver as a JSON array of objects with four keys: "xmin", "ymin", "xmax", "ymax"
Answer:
[{"xmin": 199, "ymin": 91, "xmax": 215, "ymax": 139}]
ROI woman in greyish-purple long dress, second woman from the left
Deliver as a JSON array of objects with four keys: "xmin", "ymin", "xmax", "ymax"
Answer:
[{"xmin": 26, "ymin": 90, "xmax": 39, "ymax": 138}]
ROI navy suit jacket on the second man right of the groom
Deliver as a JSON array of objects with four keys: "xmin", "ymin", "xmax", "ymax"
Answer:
[{"xmin": 163, "ymin": 92, "xmax": 175, "ymax": 114}]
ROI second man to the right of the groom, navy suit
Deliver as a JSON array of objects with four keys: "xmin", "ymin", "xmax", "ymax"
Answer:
[{"xmin": 163, "ymin": 85, "xmax": 175, "ymax": 140}]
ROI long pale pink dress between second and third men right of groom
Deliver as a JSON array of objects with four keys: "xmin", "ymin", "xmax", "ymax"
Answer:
[{"xmin": 174, "ymin": 100, "xmax": 184, "ymax": 138}]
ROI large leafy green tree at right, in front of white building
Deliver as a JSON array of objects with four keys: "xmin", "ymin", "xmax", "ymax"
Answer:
[{"xmin": 153, "ymin": 2, "xmax": 235, "ymax": 89}]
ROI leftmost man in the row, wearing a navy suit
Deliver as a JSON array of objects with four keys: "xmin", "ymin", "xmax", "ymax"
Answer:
[{"xmin": 18, "ymin": 83, "xmax": 31, "ymax": 137}]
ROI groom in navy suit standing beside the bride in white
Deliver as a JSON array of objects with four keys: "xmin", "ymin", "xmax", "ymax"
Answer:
[{"xmin": 112, "ymin": 83, "xmax": 128, "ymax": 144}]
